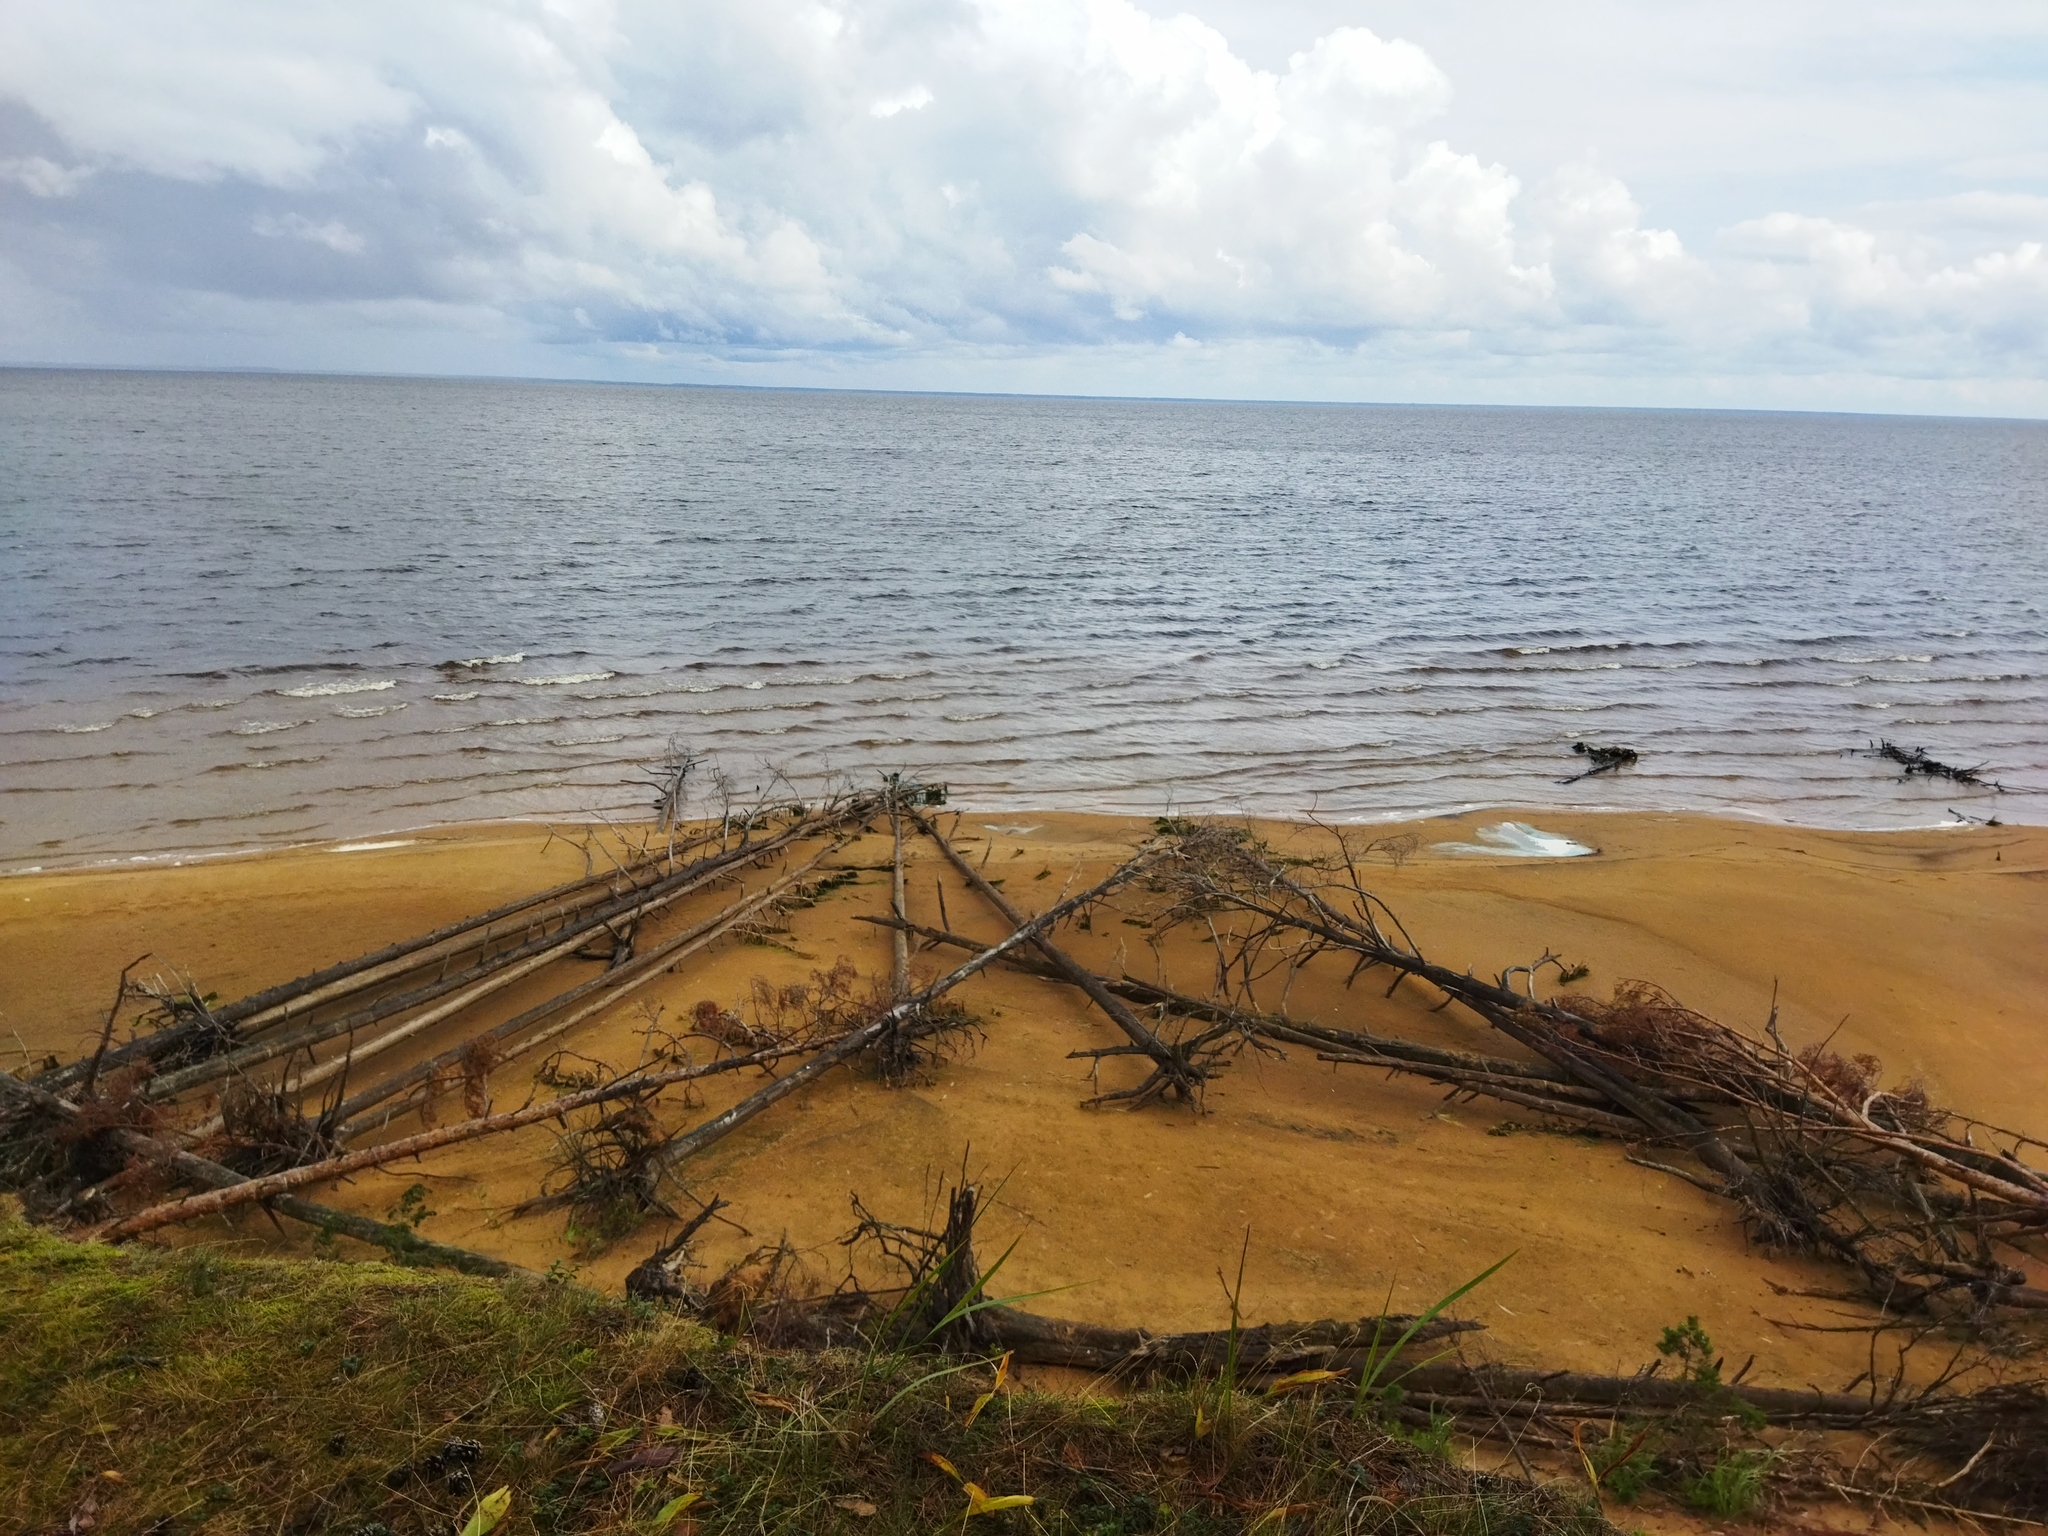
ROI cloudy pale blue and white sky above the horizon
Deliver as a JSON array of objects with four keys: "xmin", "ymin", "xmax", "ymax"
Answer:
[{"xmin": 0, "ymin": 0, "xmax": 2048, "ymax": 416}]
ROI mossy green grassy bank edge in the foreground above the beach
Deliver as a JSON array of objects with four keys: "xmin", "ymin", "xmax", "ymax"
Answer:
[{"xmin": 0, "ymin": 1204, "xmax": 1610, "ymax": 1536}]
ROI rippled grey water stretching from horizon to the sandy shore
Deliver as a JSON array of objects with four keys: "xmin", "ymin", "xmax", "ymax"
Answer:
[{"xmin": 0, "ymin": 371, "xmax": 2048, "ymax": 868}]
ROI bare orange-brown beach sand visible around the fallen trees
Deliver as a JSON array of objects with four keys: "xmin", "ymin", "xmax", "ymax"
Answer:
[{"xmin": 0, "ymin": 813, "xmax": 2048, "ymax": 1389}]
